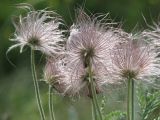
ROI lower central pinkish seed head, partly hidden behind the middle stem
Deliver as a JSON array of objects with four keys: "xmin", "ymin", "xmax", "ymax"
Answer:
[{"xmin": 67, "ymin": 65, "xmax": 106, "ymax": 97}]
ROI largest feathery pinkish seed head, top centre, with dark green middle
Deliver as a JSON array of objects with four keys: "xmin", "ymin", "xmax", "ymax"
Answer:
[{"xmin": 66, "ymin": 11, "xmax": 119, "ymax": 67}]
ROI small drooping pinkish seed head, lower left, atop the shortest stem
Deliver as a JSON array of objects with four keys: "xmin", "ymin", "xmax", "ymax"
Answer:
[{"xmin": 44, "ymin": 58, "xmax": 68, "ymax": 94}]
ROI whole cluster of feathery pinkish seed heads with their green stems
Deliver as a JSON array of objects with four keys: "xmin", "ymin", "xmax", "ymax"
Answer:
[{"xmin": 7, "ymin": 4, "xmax": 160, "ymax": 120}]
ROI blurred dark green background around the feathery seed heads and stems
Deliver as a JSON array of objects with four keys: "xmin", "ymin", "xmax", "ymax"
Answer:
[{"xmin": 0, "ymin": 0, "xmax": 160, "ymax": 120}]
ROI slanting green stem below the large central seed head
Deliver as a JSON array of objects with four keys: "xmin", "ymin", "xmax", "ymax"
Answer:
[{"xmin": 89, "ymin": 64, "xmax": 103, "ymax": 120}]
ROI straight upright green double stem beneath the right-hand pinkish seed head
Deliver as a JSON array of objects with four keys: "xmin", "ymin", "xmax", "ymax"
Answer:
[{"xmin": 127, "ymin": 78, "xmax": 134, "ymax": 120}]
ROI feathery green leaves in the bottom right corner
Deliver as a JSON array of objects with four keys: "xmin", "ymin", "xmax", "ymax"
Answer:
[{"xmin": 137, "ymin": 83, "xmax": 160, "ymax": 120}]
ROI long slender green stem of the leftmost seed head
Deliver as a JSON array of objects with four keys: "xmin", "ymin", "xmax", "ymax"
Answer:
[{"xmin": 31, "ymin": 49, "xmax": 45, "ymax": 120}]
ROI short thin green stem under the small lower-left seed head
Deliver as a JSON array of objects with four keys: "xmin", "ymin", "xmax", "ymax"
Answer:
[{"xmin": 49, "ymin": 85, "xmax": 55, "ymax": 120}]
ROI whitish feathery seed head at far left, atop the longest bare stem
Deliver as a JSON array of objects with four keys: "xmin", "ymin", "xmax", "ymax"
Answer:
[{"xmin": 8, "ymin": 4, "xmax": 64, "ymax": 55}]
